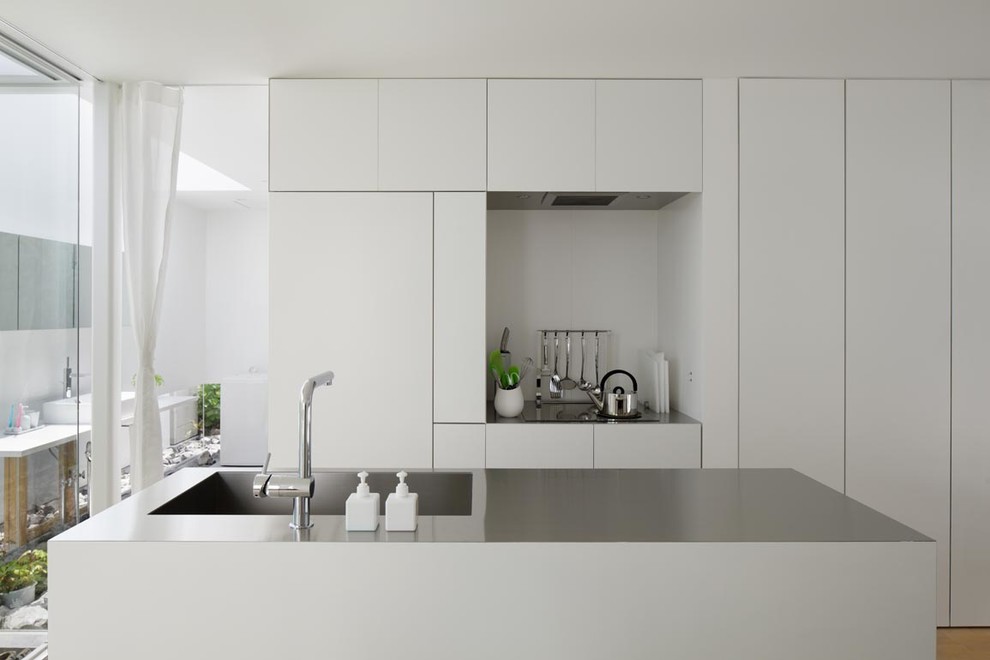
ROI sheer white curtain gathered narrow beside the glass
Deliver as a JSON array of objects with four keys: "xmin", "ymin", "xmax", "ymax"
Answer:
[{"xmin": 116, "ymin": 82, "xmax": 182, "ymax": 493}]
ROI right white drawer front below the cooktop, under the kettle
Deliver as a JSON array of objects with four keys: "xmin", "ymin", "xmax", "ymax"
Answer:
[{"xmin": 594, "ymin": 422, "xmax": 701, "ymax": 468}]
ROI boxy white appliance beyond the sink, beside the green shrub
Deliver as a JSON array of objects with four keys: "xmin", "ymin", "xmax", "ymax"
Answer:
[{"xmin": 220, "ymin": 374, "xmax": 268, "ymax": 466}]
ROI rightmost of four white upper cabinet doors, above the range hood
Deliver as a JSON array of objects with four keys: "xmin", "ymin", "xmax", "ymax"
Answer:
[{"xmin": 595, "ymin": 80, "xmax": 702, "ymax": 192}]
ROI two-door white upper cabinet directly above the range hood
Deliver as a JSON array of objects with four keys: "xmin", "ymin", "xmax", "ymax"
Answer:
[{"xmin": 488, "ymin": 80, "xmax": 701, "ymax": 192}]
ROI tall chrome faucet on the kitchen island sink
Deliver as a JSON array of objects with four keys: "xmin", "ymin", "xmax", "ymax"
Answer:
[{"xmin": 253, "ymin": 371, "xmax": 333, "ymax": 529}]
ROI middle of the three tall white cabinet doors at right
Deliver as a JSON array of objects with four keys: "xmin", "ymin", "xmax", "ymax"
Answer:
[{"xmin": 846, "ymin": 80, "xmax": 951, "ymax": 625}]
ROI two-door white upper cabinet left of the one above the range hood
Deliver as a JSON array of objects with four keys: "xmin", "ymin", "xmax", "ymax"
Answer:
[{"xmin": 269, "ymin": 80, "xmax": 486, "ymax": 192}]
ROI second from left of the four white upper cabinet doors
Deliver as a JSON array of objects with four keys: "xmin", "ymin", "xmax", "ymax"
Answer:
[{"xmin": 378, "ymin": 79, "xmax": 487, "ymax": 190}]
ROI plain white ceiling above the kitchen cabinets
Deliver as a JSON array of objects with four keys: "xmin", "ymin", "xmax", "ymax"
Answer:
[{"xmin": 0, "ymin": 0, "xmax": 990, "ymax": 83}]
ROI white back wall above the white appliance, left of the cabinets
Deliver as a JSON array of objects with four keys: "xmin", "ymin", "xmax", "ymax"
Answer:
[{"xmin": 204, "ymin": 209, "xmax": 268, "ymax": 383}]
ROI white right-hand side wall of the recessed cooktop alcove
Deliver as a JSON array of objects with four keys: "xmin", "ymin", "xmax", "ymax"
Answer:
[{"xmin": 656, "ymin": 194, "xmax": 704, "ymax": 419}]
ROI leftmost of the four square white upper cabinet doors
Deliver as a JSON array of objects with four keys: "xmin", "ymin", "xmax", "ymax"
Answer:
[{"xmin": 268, "ymin": 80, "xmax": 378, "ymax": 191}]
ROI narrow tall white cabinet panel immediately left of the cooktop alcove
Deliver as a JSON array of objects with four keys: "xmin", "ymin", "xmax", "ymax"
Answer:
[{"xmin": 433, "ymin": 193, "xmax": 488, "ymax": 424}]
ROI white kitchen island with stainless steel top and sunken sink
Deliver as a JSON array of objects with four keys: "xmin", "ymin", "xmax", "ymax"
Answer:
[{"xmin": 49, "ymin": 468, "xmax": 935, "ymax": 660}]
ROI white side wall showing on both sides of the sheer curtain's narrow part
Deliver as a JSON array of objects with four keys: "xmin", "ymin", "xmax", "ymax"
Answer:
[{"xmin": 120, "ymin": 203, "xmax": 207, "ymax": 392}]
